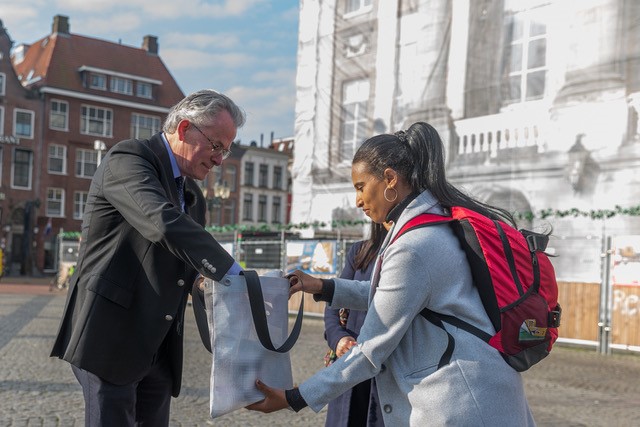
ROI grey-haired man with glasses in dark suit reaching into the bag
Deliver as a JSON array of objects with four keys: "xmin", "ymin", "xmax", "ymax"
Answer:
[{"xmin": 51, "ymin": 90, "xmax": 245, "ymax": 427}]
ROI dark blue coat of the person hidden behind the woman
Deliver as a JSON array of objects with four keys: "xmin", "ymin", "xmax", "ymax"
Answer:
[{"xmin": 324, "ymin": 241, "xmax": 384, "ymax": 427}]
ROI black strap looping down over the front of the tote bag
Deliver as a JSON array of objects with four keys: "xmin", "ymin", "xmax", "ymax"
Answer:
[{"xmin": 240, "ymin": 270, "xmax": 304, "ymax": 353}]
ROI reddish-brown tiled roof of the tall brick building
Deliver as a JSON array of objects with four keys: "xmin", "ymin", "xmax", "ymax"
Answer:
[{"xmin": 12, "ymin": 33, "xmax": 184, "ymax": 107}]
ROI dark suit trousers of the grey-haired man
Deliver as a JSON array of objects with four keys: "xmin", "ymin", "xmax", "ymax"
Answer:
[{"xmin": 71, "ymin": 352, "xmax": 172, "ymax": 427}]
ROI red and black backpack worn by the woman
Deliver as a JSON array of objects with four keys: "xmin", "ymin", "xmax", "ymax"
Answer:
[{"xmin": 393, "ymin": 206, "xmax": 562, "ymax": 372}]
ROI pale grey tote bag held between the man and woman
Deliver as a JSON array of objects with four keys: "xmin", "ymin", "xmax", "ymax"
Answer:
[{"xmin": 204, "ymin": 270, "xmax": 303, "ymax": 418}]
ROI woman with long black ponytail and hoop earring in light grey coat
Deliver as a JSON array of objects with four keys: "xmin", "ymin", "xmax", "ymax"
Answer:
[{"xmin": 248, "ymin": 122, "xmax": 535, "ymax": 426}]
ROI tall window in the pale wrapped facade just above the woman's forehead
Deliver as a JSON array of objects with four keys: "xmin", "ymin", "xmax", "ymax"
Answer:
[{"xmin": 340, "ymin": 80, "xmax": 369, "ymax": 162}]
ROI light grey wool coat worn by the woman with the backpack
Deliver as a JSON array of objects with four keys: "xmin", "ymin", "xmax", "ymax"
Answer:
[{"xmin": 299, "ymin": 191, "xmax": 535, "ymax": 427}]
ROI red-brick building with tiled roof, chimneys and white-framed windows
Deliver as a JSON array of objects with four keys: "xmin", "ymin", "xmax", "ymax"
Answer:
[{"xmin": 6, "ymin": 15, "xmax": 184, "ymax": 274}]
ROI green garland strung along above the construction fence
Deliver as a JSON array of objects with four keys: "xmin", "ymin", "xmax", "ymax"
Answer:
[{"xmin": 62, "ymin": 205, "xmax": 640, "ymax": 240}]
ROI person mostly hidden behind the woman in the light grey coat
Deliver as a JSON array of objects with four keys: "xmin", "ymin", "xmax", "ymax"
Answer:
[{"xmin": 324, "ymin": 222, "xmax": 387, "ymax": 427}]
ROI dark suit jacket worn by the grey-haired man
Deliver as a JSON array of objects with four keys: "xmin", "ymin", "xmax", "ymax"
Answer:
[{"xmin": 51, "ymin": 134, "xmax": 233, "ymax": 396}]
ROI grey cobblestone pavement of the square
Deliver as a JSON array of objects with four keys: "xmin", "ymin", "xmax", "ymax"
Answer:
[{"xmin": 0, "ymin": 285, "xmax": 640, "ymax": 427}]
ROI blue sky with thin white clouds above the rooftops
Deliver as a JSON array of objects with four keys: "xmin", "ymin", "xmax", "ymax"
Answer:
[{"xmin": 0, "ymin": 0, "xmax": 299, "ymax": 146}]
